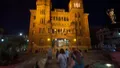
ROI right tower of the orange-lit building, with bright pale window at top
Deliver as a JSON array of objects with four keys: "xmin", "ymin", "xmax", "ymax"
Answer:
[{"xmin": 69, "ymin": 0, "xmax": 90, "ymax": 48}]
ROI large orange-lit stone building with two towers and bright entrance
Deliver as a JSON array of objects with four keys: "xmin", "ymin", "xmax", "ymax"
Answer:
[{"xmin": 28, "ymin": 0, "xmax": 91, "ymax": 52}]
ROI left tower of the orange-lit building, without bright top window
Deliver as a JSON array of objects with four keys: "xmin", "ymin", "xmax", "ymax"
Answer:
[{"xmin": 28, "ymin": 0, "xmax": 51, "ymax": 51}]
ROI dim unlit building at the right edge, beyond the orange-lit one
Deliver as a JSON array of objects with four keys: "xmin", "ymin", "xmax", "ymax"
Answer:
[{"xmin": 96, "ymin": 23, "xmax": 120, "ymax": 48}]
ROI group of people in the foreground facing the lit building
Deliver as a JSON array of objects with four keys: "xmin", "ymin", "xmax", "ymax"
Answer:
[{"xmin": 56, "ymin": 49, "xmax": 84, "ymax": 68}]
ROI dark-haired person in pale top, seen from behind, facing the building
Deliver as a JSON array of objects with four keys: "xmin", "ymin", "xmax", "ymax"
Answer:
[{"xmin": 58, "ymin": 49, "xmax": 67, "ymax": 68}]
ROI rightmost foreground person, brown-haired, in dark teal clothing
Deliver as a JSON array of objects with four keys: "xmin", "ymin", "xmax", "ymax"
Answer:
[{"xmin": 72, "ymin": 50, "xmax": 84, "ymax": 68}]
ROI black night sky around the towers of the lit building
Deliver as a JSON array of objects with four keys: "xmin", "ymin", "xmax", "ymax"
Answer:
[{"xmin": 0, "ymin": 0, "xmax": 120, "ymax": 34}]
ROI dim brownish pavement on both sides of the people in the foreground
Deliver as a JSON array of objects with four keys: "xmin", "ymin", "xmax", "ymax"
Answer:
[{"xmin": 0, "ymin": 51, "xmax": 111, "ymax": 68}]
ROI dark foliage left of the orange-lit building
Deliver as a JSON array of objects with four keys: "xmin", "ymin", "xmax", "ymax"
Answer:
[{"xmin": 0, "ymin": 37, "xmax": 26, "ymax": 65}]
